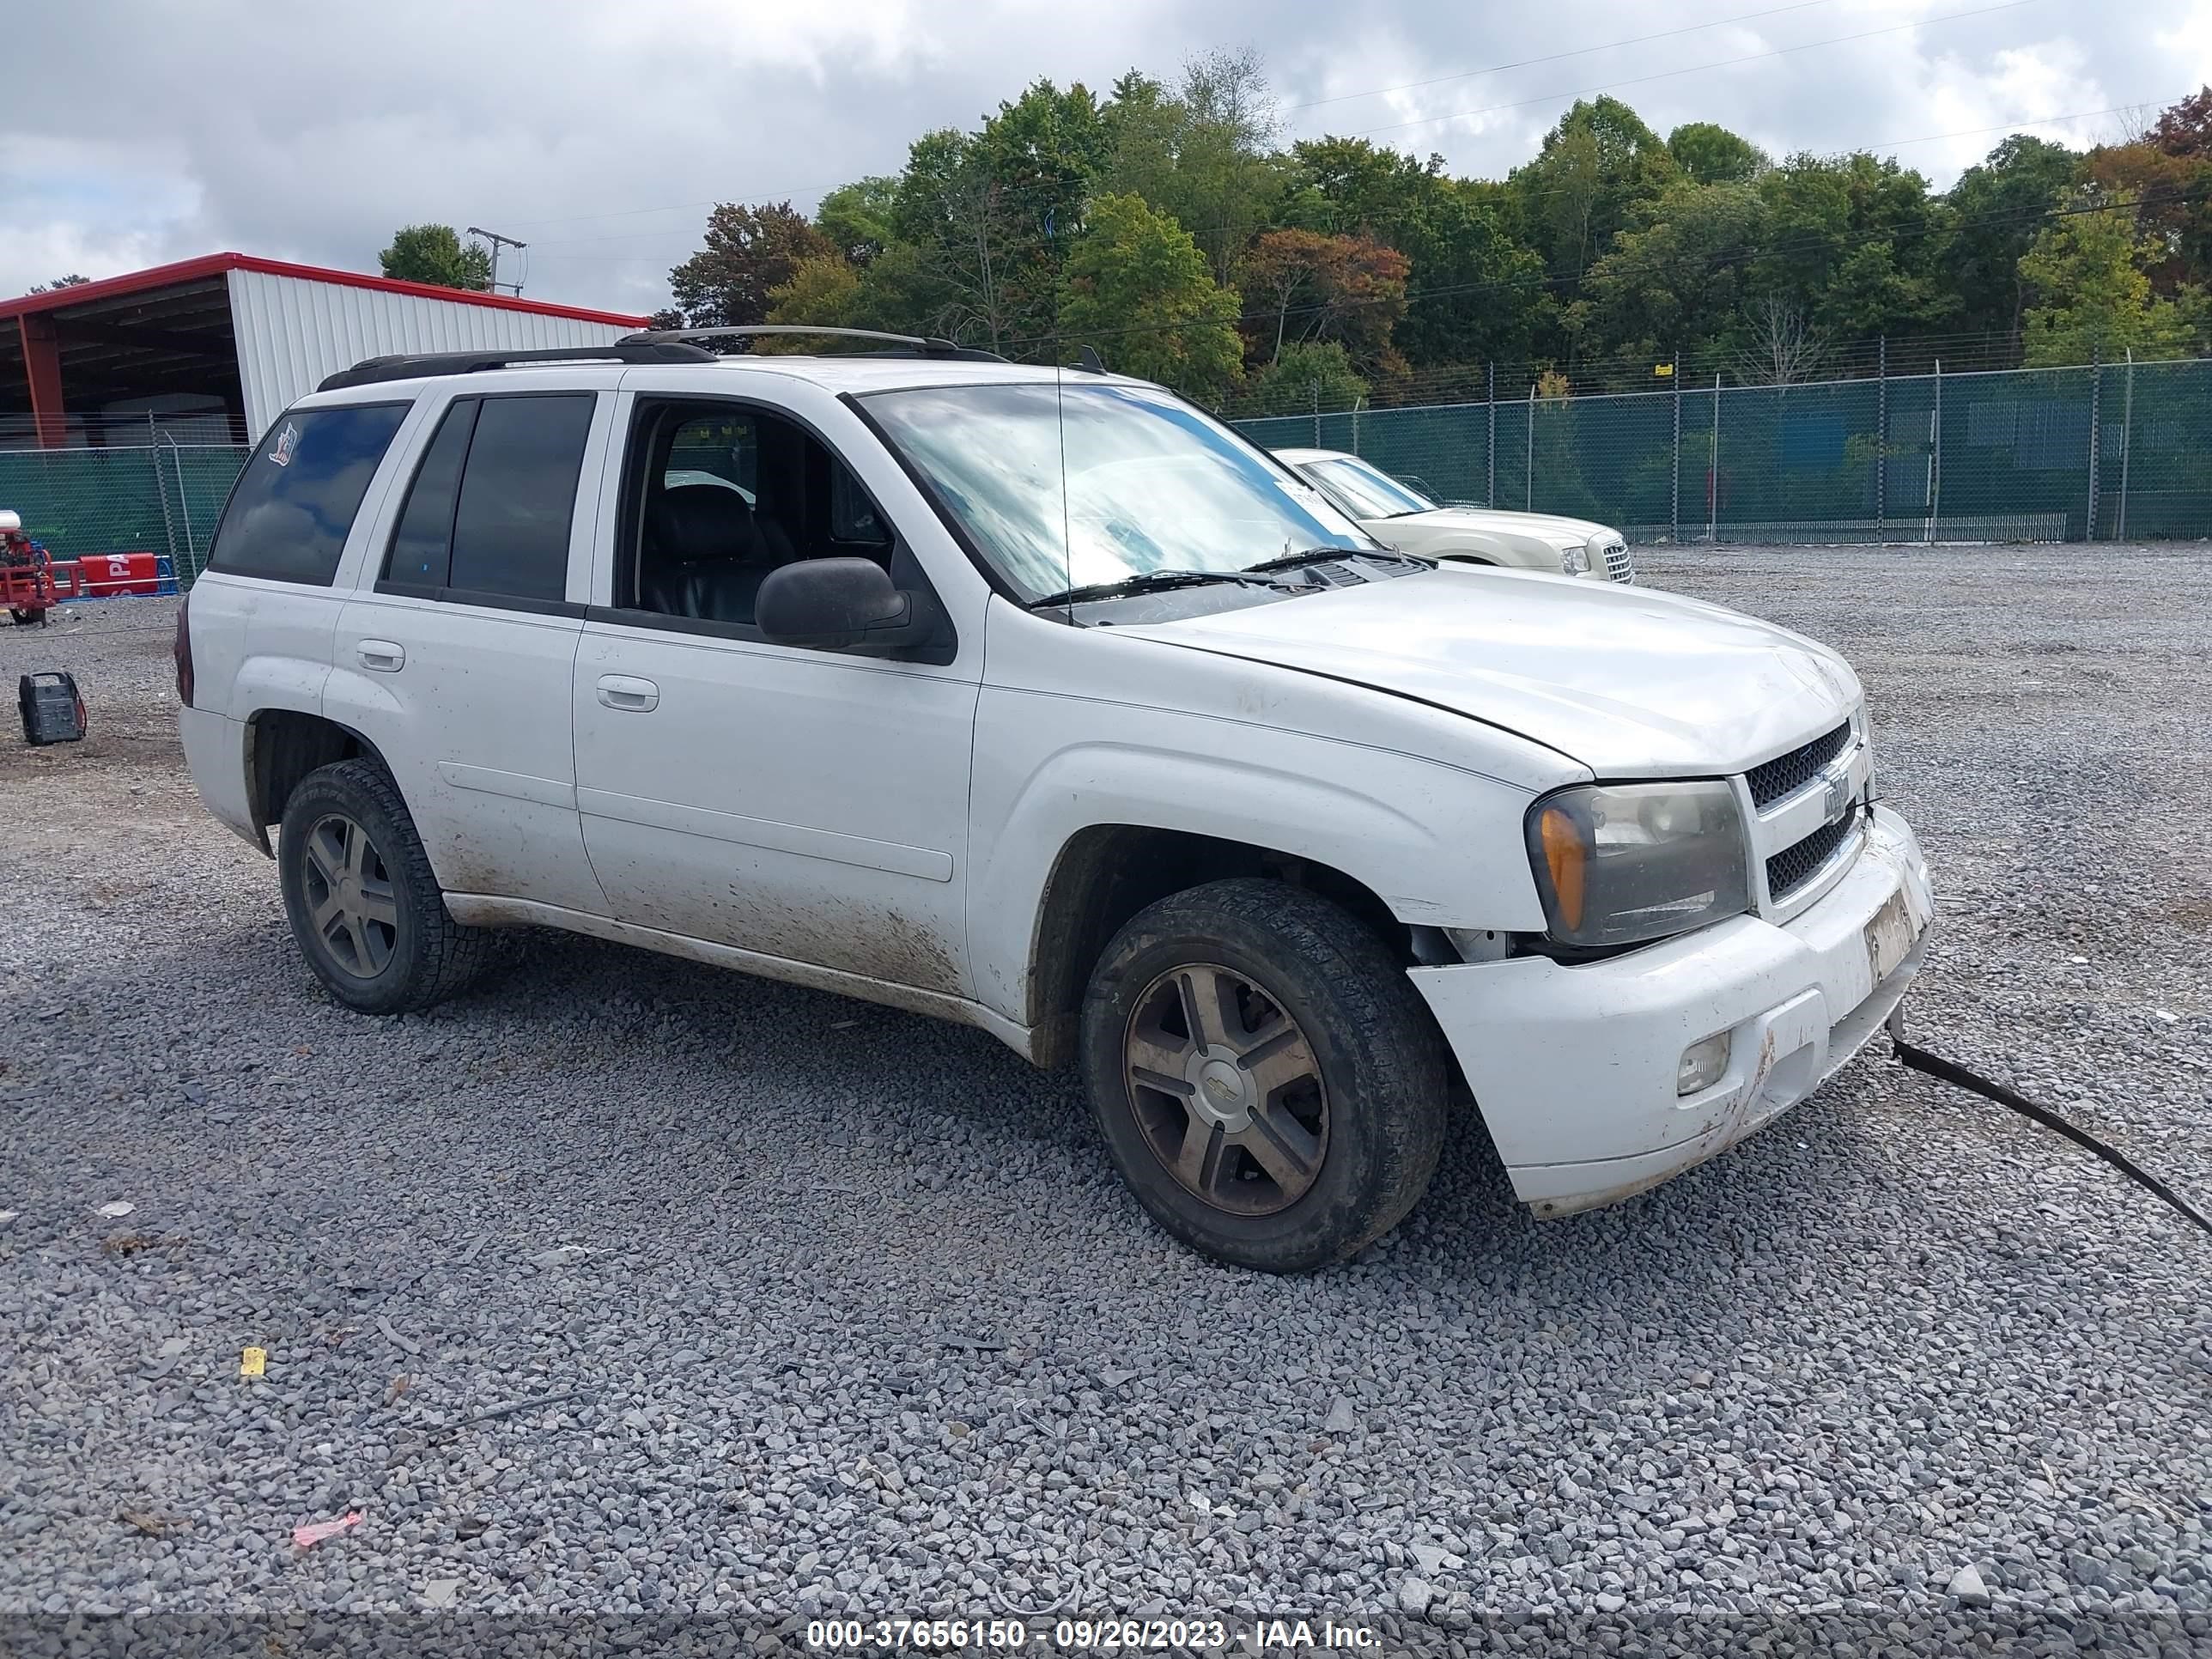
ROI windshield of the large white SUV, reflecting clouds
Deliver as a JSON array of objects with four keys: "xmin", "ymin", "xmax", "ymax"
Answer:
[{"xmin": 865, "ymin": 380, "xmax": 1374, "ymax": 602}]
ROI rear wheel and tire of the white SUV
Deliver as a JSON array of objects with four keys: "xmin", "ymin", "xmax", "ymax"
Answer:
[{"xmin": 276, "ymin": 759, "xmax": 489, "ymax": 1013}]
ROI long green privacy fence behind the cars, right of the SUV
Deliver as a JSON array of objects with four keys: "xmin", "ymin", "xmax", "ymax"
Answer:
[{"xmin": 1237, "ymin": 361, "xmax": 2212, "ymax": 542}]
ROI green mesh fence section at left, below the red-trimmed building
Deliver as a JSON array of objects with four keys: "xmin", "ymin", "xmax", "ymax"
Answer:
[{"xmin": 0, "ymin": 441, "xmax": 252, "ymax": 586}]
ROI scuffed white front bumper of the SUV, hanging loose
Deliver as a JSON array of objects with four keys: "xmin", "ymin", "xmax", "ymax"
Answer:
[{"xmin": 1411, "ymin": 807, "xmax": 1936, "ymax": 1214}]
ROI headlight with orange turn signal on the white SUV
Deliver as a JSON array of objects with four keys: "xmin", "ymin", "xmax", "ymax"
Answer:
[{"xmin": 1528, "ymin": 781, "xmax": 1752, "ymax": 945}]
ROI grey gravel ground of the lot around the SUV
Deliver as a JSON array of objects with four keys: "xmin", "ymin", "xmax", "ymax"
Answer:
[{"xmin": 0, "ymin": 546, "xmax": 2212, "ymax": 1652}]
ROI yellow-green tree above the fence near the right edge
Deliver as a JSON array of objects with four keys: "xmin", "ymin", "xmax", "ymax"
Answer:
[{"xmin": 2020, "ymin": 192, "xmax": 2203, "ymax": 368}]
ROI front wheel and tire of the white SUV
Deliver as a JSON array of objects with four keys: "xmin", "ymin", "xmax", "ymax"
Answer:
[{"xmin": 1082, "ymin": 878, "xmax": 1449, "ymax": 1274}]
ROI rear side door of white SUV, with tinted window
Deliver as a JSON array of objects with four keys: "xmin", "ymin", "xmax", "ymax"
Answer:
[{"xmin": 325, "ymin": 374, "xmax": 613, "ymax": 914}]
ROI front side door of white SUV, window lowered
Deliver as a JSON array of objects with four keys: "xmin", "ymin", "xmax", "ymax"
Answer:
[{"xmin": 571, "ymin": 378, "xmax": 982, "ymax": 995}]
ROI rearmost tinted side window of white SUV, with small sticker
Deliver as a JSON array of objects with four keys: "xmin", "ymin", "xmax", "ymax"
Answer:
[{"xmin": 208, "ymin": 403, "xmax": 407, "ymax": 584}]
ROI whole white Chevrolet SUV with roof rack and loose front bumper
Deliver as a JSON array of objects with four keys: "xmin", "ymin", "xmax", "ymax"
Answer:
[{"xmin": 177, "ymin": 337, "xmax": 1933, "ymax": 1270}]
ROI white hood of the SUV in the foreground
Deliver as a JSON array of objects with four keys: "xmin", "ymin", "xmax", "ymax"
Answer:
[{"xmin": 1121, "ymin": 566, "xmax": 1860, "ymax": 779}]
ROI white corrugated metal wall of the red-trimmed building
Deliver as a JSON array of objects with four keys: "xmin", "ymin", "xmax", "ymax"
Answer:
[{"xmin": 230, "ymin": 270, "xmax": 630, "ymax": 442}]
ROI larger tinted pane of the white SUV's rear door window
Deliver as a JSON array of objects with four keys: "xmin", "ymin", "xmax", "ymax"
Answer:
[{"xmin": 447, "ymin": 392, "xmax": 592, "ymax": 599}]
